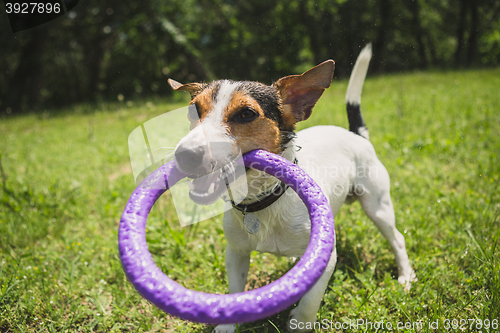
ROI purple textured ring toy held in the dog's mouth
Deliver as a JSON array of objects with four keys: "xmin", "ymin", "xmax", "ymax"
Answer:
[{"xmin": 118, "ymin": 150, "xmax": 335, "ymax": 324}]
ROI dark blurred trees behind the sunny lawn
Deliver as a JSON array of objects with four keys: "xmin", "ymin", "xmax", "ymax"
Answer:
[{"xmin": 0, "ymin": 0, "xmax": 500, "ymax": 115}]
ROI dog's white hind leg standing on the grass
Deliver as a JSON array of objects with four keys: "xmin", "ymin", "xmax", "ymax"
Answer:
[{"xmin": 359, "ymin": 164, "xmax": 416, "ymax": 291}]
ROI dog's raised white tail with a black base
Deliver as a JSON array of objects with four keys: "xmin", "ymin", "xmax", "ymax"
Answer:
[{"xmin": 345, "ymin": 43, "xmax": 372, "ymax": 139}]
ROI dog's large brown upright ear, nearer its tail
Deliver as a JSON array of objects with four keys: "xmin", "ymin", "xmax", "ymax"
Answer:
[{"xmin": 273, "ymin": 59, "xmax": 335, "ymax": 123}]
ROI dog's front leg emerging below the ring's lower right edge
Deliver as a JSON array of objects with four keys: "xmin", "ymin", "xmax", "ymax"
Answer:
[{"xmin": 287, "ymin": 244, "xmax": 337, "ymax": 333}]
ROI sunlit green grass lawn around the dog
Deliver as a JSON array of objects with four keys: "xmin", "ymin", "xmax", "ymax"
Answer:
[{"xmin": 0, "ymin": 69, "xmax": 500, "ymax": 333}]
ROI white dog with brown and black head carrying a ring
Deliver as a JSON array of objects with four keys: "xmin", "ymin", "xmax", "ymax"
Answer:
[{"xmin": 169, "ymin": 46, "xmax": 414, "ymax": 333}]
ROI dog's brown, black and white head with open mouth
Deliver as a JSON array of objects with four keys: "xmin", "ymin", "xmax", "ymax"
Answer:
[{"xmin": 168, "ymin": 60, "xmax": 335, "ymax": 204}]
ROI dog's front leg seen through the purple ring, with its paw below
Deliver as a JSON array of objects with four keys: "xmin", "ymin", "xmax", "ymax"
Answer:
[{"xmin": 213, "ymin": 245, "xmax": 250, "ymax": 333}]
